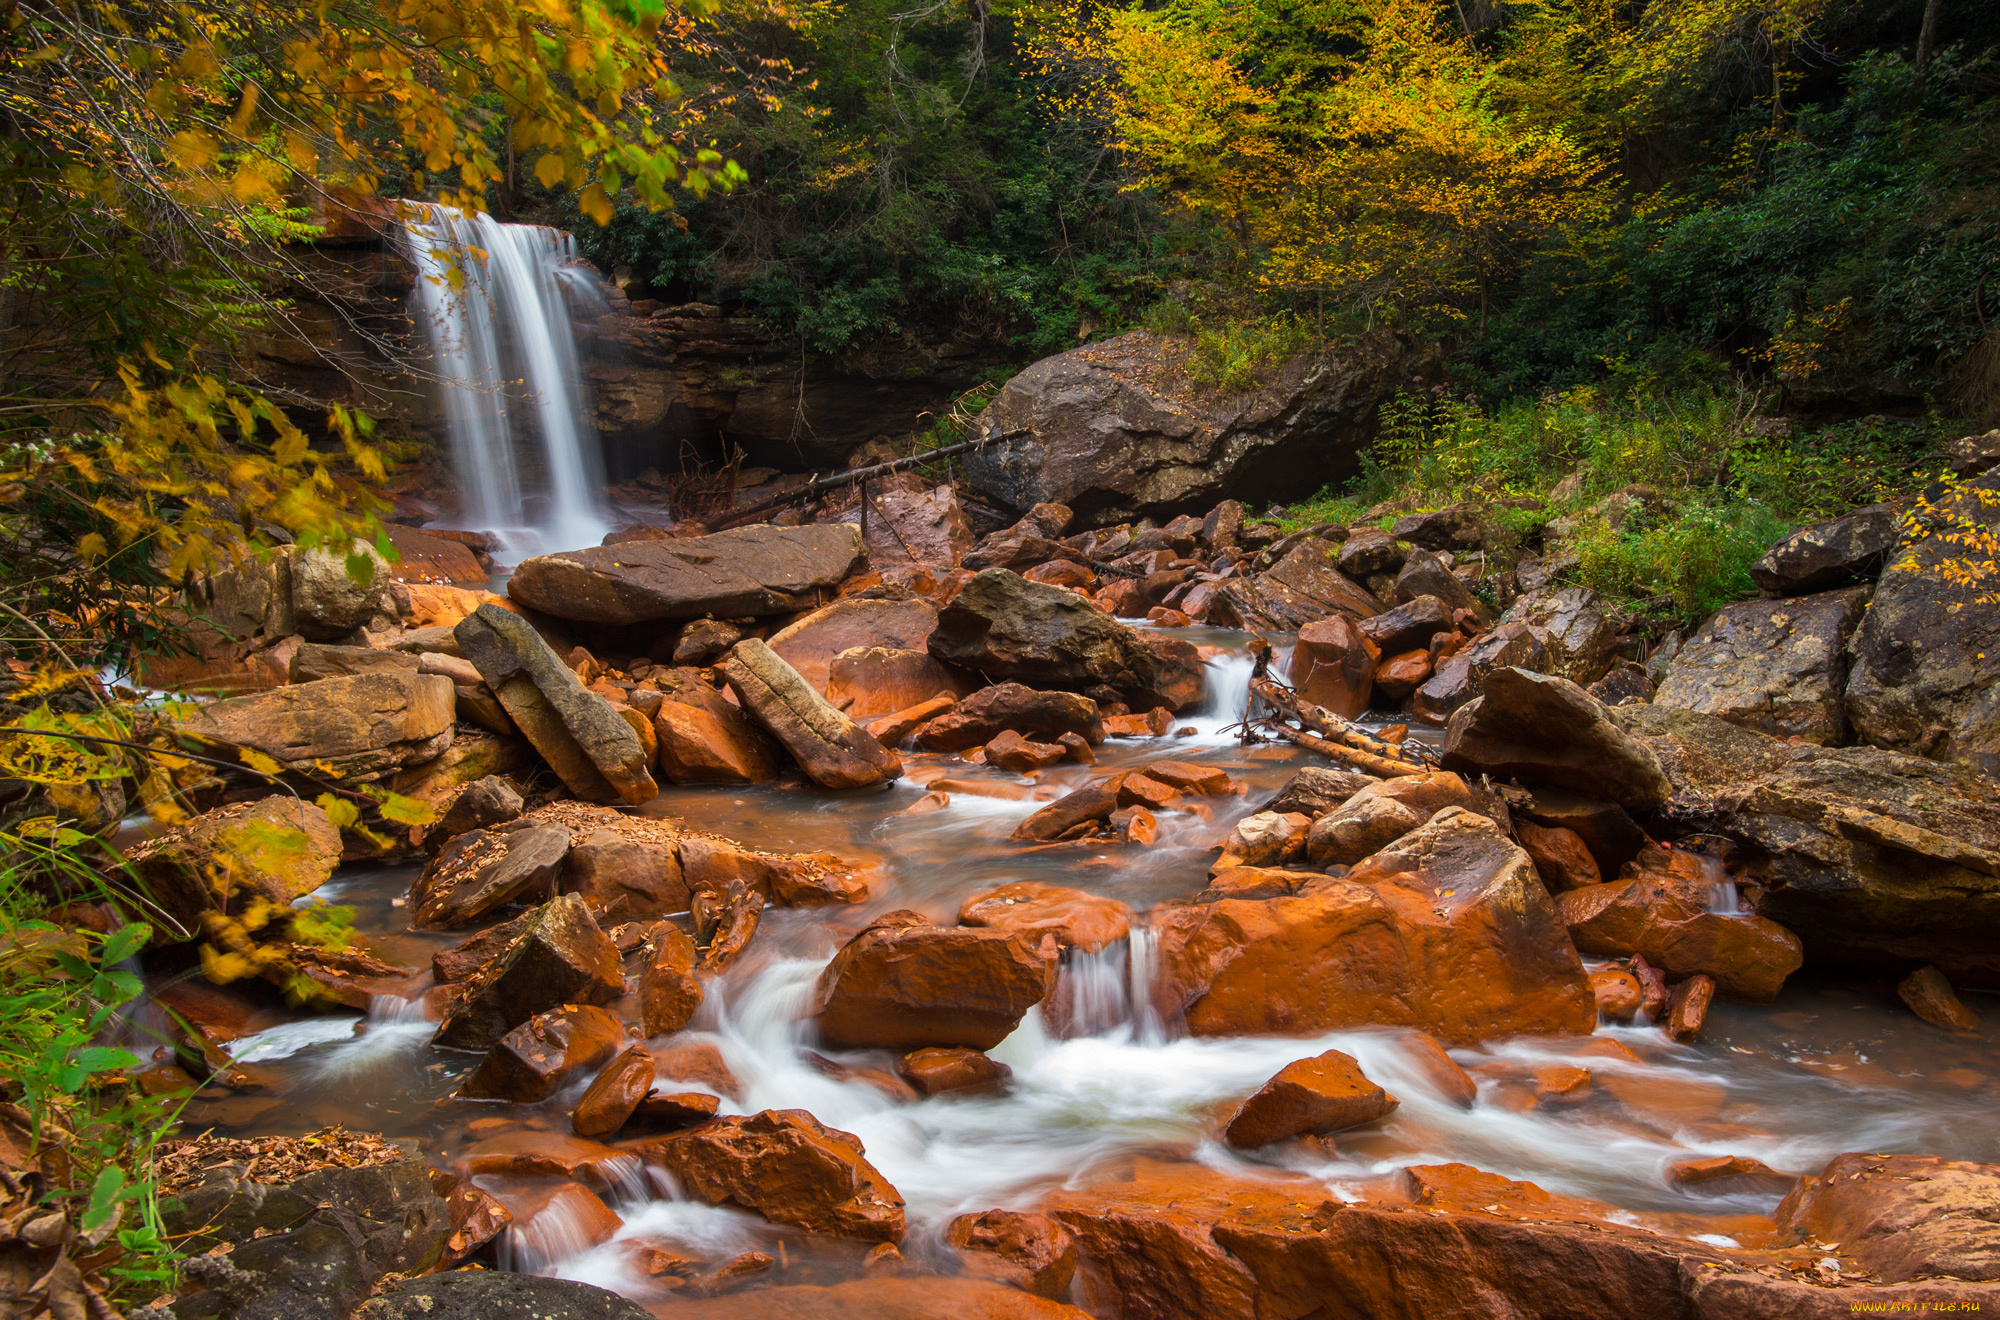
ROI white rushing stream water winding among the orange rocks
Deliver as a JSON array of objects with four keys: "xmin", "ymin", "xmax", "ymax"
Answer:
[{"xmin": 176, "ymin": 632, "xmax": 2000, "ymax": 1300}]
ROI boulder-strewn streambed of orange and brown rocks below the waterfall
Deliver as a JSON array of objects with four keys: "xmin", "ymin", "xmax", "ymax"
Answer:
[{"xmin": 121, "ymin": 476, "xmax": 2000, "ymax": 1320}]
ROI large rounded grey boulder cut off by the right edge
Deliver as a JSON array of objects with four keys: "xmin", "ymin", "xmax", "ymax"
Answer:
[{"xmin": 1848, "ymin": 472, "xmax": 2000, "ymax": 774}]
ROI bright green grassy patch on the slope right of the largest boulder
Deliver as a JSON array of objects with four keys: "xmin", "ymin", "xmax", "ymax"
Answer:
[{"xmin": 1278, "ymin": 388, "xmax": 1964, "ymax": 632}]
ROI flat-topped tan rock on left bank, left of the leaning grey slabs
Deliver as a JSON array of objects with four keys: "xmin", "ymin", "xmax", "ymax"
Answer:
[{"xmin": 176, "ymin": 670, "xmax": 456, "ymax": 780}]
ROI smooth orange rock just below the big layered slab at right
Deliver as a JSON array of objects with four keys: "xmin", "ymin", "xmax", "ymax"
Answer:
[{"xmin": 1556, "ymin": 880, "xmax": 1804, "ymax": 1004}]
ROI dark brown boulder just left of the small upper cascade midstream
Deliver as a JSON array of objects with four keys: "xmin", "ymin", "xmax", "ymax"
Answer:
[{"xmin": 930, "ymin": 568, "xmax": 1204, "ymax": 710}]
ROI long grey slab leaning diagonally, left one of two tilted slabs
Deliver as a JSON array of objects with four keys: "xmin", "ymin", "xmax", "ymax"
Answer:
[{"xmin": 452, "ymin": 604, "xmax": 660, "ymax": 804}]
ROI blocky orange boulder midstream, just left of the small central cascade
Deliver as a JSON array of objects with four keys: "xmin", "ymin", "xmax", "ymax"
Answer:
[{"xmin": 816, "ymin": 912, "xmax": 1056, "ymax": 1050}]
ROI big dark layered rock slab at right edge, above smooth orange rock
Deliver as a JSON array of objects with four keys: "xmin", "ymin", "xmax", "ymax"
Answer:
[{"xmin": 1610, "ymin": 706, "xmax": 2000, "ymax": 988}]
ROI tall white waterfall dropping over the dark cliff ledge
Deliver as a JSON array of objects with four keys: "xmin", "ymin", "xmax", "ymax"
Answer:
[{"xmin": 404, "ymin": 202, "xmax": 610, "ymax": 560}]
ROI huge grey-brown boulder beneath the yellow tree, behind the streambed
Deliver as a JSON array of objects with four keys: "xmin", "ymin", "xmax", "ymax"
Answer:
[{"xmin": 966, "ymin": 330, "xmax": 1424, "ymax": 526}]
